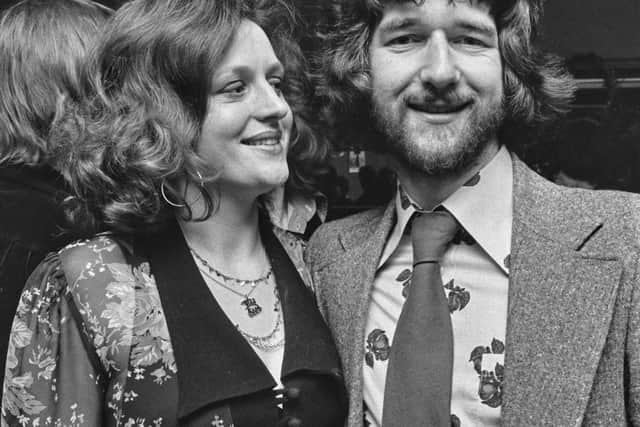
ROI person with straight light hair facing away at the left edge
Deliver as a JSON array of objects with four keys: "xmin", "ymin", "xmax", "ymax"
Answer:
[{"xmin": 0, "ymin": 0, "xmax": 110, "ymax": 394}]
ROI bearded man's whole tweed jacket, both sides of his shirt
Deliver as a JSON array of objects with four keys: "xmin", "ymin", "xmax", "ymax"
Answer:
[{"xmin": 307, "ymin": 156, "xmax": 640, "ymax": 427}]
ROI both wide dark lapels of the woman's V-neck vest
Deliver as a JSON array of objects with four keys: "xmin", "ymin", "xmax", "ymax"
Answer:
[{"xmin": 140, "ymin": 219, "xmax": 340, "ymax": 418}]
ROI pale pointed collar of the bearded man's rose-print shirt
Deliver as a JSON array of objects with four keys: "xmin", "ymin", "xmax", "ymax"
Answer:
[{"xmin": 378, "ymin": 147, "xmax": 513, "ymax": 274}]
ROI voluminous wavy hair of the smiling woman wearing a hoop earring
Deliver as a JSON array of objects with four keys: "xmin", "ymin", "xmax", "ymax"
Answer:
[{"xmin": 53, "ymin": 0, "xmax": 328, "ymax": 234}]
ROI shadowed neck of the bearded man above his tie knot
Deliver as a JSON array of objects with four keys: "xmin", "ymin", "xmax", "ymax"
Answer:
[{"xmin": 393, "ymin": 142, "xmax": 500, "ymax": 210}]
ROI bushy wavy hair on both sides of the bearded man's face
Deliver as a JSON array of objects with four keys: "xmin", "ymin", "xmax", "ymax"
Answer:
[{"xmin": 314, "ymin": 0, "xmax": 575, "ymax": 152}]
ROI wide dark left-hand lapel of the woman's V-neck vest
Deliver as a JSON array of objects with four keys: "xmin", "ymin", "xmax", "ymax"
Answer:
[{"xmin": 140, "ymin": 221, "xmax": 276, "ymax": 418}]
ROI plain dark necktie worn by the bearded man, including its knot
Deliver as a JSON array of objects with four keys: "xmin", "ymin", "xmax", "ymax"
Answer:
[{"xmin": 382, "ymin": 211, "xmax": 458, "ymax": 427}]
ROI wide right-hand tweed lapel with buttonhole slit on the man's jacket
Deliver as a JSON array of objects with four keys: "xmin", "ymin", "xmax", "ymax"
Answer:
[{"xmin": 502, "ymin": 159, "xmax": 622, "ymax": 425}]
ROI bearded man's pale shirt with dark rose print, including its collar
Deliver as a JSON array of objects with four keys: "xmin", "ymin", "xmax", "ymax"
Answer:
[{"xmin": 363, "ymin": 148, "xmax": 513, "ymax": 426}]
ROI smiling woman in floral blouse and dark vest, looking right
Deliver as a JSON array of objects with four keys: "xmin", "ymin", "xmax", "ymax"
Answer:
[{"xmin": 3, "ymin": 0, "xmax": 345, "ymax": 427}]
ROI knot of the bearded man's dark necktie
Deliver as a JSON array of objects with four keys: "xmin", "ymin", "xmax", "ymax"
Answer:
[{"xmin": 411, "ymin": 211, "xmax": 459, "ymax": 262}]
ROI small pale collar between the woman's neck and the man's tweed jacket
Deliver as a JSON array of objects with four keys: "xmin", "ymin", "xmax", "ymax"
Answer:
[{"xmin": 261, "ymin": 186, "xmax": 327, "ymax": 234}]
